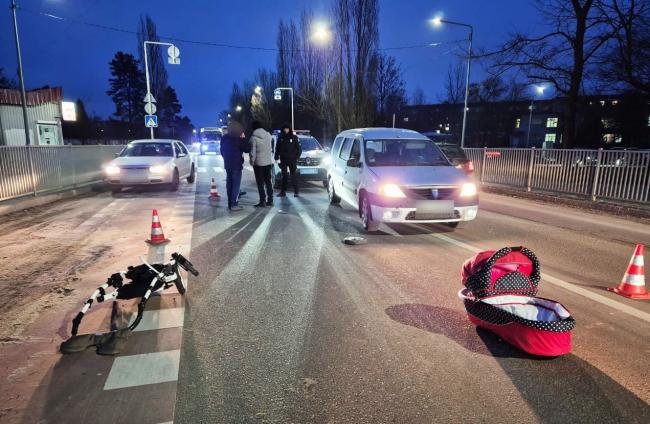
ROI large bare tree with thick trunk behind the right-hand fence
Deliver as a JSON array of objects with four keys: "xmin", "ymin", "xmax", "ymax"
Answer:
[{"xmin": 493, "ymin": 0, "xmax": 611, "ymax": 148}]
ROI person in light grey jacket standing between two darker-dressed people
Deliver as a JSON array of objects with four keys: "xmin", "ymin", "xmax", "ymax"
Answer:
[{"xmin": 250, "ymin": 121, "xmax": 273, "ymax": 208}]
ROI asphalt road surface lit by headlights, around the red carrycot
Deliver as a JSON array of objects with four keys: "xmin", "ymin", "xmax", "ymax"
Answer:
[{"xmin": 0, "ymin": 156, "xmax": 650, "ymax": 423}]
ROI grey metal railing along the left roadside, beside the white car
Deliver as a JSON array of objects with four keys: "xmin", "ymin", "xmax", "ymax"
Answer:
[{"xmin": 0, "ymin": 146, "xmax": 124, "ymax": 201}]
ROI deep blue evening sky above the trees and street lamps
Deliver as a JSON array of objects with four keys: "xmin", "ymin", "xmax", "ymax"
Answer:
[{"xmin": 0, "ymin": 0, "xmax": 538, "ymax": 126}]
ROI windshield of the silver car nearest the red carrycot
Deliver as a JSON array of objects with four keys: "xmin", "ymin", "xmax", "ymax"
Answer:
[{"xmin": 365, "ymin": 140, "xmax": 450, "ymax": 166}]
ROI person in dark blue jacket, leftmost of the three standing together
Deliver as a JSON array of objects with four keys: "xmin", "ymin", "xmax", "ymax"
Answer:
[{"xmin": 221, "ymin": 121, "xmax": 250, "ymax": 211}]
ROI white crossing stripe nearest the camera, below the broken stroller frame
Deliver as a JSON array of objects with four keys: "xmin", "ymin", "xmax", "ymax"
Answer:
[{"xmin": 104, "ymin": 349, "xmax": 181, "ymax": 390}]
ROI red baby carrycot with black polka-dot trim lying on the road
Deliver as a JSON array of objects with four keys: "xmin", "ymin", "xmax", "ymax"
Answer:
[{"xmin": 458, "ymin": 247, "xmax": 575, "ymax": 356}]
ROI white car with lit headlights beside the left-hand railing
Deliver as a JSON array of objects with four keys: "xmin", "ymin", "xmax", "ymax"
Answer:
[{"xmin": 103, "ymin": 139, "xmax": 196, "ymax": 193}]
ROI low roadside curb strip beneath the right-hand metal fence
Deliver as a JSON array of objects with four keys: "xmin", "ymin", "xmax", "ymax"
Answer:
[{"xmin": 481, "ymin": 184, "xmax": 650, "ymax": 223}]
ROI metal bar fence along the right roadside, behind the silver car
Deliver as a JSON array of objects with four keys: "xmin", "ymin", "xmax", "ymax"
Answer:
[{"xmin": 465, "ymin": 148, "xmax": 650, "ymax": 204}]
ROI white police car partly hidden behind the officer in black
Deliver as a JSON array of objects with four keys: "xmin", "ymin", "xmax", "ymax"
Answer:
[{"xmin": 272, "ymin": 131, "xmax": 330, "ymax": 188}]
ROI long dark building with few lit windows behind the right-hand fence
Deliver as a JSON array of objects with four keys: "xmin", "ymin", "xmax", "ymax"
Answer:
[{"xmin": 398, "ymin": 93, "xmax": 650, "ymax": 149}]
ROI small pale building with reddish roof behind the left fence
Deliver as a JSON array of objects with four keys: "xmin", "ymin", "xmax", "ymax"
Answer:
[{"xmin": 0, "ymin": 87, "xmax": 63, "ymax": 146}]
